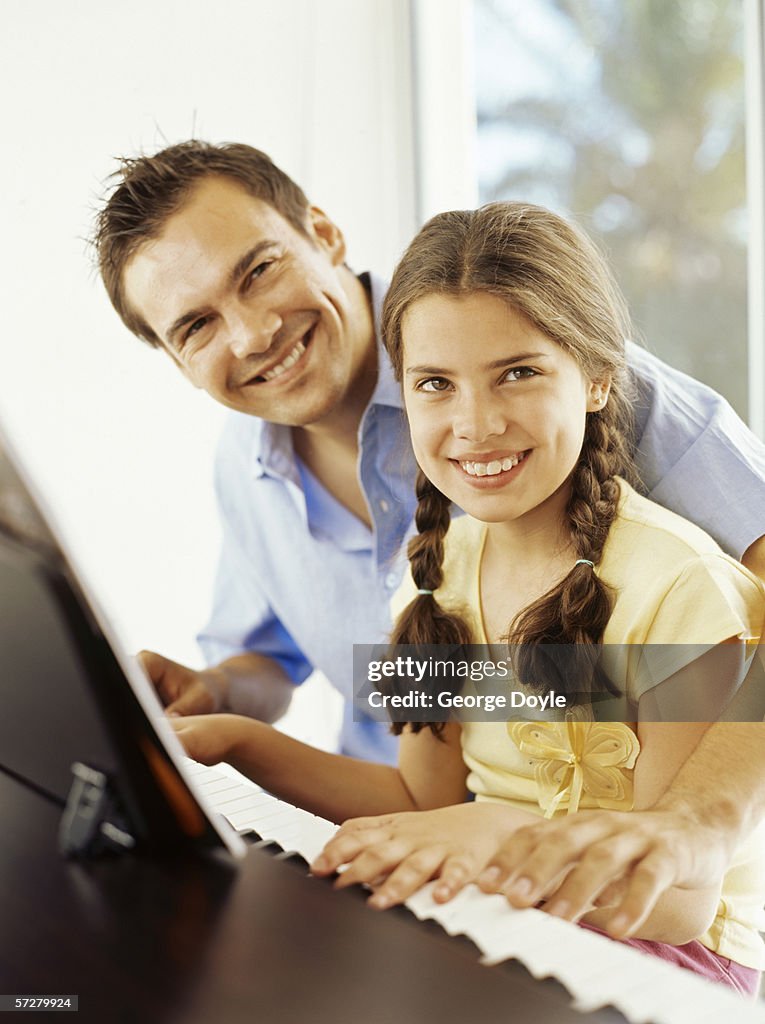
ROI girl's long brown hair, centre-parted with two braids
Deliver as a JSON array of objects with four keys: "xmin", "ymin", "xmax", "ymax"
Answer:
[{"xmin": 382, "ymin": 203, "xmax": 633, "ymax": 733}]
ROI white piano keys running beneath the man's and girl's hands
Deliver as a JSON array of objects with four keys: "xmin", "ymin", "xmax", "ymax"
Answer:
[{"xmin": 186, "ymin": 761, "xmax": 765, "ymax": 1024}]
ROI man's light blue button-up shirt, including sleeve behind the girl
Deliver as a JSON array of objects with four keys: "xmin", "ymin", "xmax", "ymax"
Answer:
[{"xmin": 199, "ymin": 278, "xmax": 765, "ymax": 761}]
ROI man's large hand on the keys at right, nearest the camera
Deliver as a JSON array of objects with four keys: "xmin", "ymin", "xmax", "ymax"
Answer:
[{"xmin": 478, "ymin": 808, "xmax": 731, "ymax": 938}]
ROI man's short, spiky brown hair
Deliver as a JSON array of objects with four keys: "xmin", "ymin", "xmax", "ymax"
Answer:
[{"xmin": 93, "ymin": 139, "xmax": 308, "ymax": 347}]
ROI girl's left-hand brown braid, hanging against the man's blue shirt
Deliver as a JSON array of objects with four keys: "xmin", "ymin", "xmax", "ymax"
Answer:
[{"xmin": 380, "ymin": 470, "xmax": 473, "ymax": 735}]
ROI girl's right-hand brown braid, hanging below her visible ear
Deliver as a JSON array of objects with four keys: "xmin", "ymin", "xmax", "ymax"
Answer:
[{"xmin": 510, "ymin": 407, "xmax": 629, "ymax": 703}]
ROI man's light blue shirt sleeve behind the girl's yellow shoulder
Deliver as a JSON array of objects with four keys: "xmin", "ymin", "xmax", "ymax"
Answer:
[{"xmin": 627, "ymin": 344, "xmax": 765, "ymax": 558}]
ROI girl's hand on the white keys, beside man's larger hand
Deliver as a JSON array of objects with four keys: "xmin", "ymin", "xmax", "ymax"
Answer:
[{"xmin": 311, "ymin": 804, "xmax": 535, "ymax": 910}]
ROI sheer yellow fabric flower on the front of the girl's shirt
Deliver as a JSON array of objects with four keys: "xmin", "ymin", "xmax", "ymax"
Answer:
[{"xmin": 507, "ymin": 722, "xmax": 640, "ymax": 818}]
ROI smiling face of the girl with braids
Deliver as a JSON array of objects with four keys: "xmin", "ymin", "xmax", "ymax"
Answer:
[{"xmin": 401, "ymin": 292, "xmax": 607, "ymax": 523}]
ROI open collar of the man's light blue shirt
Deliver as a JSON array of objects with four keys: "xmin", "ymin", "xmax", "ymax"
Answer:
[{"xmin": 246, "ymin": 273, "xmax": 403, "ymax": 483}]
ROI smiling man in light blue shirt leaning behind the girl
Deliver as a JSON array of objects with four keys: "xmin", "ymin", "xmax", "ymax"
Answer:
[{"xmin": 95, "ymin": 141, "xmax": 765, "ymax": 929}]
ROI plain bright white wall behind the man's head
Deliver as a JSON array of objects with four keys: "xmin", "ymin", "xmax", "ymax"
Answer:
[{"xmin": 0, "ymin": 0, "xmax": 415, "ymax": 662}]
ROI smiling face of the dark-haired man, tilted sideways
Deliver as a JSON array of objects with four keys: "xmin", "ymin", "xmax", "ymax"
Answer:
[{"xmin": 124, "ymin": 177, "xmax": 369, "ymax": 426}]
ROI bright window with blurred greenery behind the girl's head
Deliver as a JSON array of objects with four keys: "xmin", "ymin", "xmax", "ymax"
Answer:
[{"xmin": 473, "ymin": 0, "xmax": 749, "ymax": 418}]
